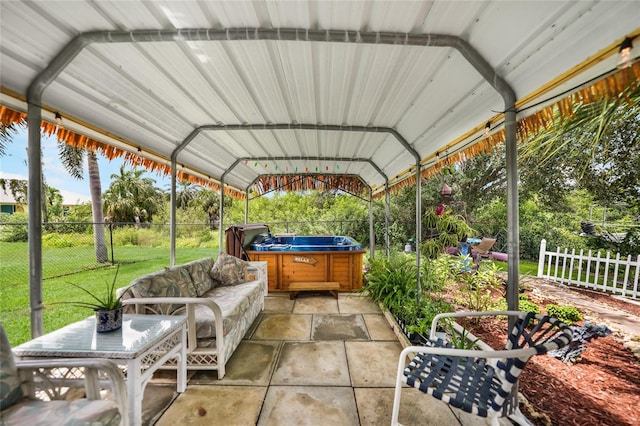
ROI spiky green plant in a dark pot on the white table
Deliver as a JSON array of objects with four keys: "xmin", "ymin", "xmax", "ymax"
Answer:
[{"xmin": 69, "ymin": 265, "xmax": 125, "ymax": 333}]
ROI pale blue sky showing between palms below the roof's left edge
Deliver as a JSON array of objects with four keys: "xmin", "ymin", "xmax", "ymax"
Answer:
[{"xmin": 0, "ymin": 128, "xmax": 171, "ymax": 204}]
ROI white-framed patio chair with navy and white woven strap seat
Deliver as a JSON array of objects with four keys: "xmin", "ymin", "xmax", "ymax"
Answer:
[{"xmin": 391, "ymin": 311, "xmax": 573, "ymax": 425}]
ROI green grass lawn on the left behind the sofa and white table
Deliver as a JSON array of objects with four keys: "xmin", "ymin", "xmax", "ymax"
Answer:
[{"xmin": 0, "ymin": 242, "xmax": 217, "ymax": 346}]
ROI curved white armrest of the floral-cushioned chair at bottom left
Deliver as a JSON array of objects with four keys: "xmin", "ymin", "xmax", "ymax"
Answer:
[{"xmin": 16, "ymin": 358, "xmax": 128, "ymax": 422}]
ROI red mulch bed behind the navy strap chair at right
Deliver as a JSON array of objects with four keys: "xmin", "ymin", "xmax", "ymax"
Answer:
[{"xmin": 469, "ymin": 290, "xmax": 640, "ymax": 426}]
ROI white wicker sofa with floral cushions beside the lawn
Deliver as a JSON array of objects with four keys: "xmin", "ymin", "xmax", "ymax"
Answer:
[{"xmin": 120, "ymin": 253, "xmax": 268, "ymax": 379}]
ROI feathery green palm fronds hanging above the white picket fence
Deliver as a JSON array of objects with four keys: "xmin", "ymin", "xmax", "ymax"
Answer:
[{"xmin": 519, "ymin": 85, "xmax": 640, "ymax": 214}]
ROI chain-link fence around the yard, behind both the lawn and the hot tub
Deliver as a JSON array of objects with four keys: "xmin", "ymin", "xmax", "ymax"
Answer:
[{"xmin": 0, "ymin": 220, "xmax": 506, "ymax": 291}]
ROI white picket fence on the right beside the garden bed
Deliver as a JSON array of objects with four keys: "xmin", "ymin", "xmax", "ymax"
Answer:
[{"xmin": 538, "ymin": 240, "xmax": 640, "ymax": 299}]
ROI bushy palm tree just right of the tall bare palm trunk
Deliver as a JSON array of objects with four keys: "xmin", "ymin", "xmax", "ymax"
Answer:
[{"xmin": 104, "ymin": 165, "xmax": 164, "ymax": 224}]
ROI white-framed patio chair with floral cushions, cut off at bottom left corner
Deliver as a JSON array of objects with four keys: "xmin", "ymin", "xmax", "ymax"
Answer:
[{"xmin": 0, "ymin": 324, "xmax": 129, "ymax": 425}]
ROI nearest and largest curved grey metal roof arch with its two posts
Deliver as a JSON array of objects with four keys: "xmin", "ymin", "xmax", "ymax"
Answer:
[{"xmin": 27, "ymin": 28, "xmax": 519, "ymax": 336}]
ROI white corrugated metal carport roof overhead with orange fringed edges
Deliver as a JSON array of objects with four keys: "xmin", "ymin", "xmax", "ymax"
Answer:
[{"xmin": 0, "ymin": 0, "xmax": 640, "ymax": 338}]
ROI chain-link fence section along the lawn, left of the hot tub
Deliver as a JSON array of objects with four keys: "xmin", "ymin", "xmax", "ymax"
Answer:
[{"xmin": 0, "ymin": 222, "xmax": 218, "ymax": 288}]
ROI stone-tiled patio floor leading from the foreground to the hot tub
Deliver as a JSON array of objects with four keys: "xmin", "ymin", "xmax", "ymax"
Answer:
[{"xmin": 138, "ymin": 292, "xmax": 510, "ymax": 426}]
